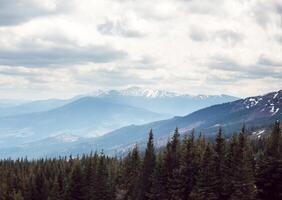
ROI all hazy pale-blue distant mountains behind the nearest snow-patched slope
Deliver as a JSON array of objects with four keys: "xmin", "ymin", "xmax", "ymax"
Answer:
[{"xmin": 0, "ymin": 87, "xmax": 237, "ymax": 146}]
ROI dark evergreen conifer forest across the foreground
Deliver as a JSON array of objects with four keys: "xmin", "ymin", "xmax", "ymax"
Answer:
[{"xmin": 0, "ymin": 122, "xmax": 282, "ymax": 200}]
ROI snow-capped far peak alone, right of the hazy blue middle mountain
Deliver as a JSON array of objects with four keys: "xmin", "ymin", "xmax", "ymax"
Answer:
[{"xmin": 89, "ymin": 87, "xmax": 238, "ymax": 117}]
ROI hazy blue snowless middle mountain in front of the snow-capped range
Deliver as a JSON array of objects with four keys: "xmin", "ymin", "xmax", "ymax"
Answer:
[{"xmin": 0, "ymin": 97, "xmax": 165, "ymax": 146}]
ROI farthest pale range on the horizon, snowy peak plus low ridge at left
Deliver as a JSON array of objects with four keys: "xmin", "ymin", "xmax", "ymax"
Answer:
[{"xmin": 0, "ymin": 87, "xmax": 237, "ymax": 117}]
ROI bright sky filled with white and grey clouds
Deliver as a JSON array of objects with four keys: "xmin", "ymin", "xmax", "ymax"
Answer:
[{"xmin": 0, "ymin": 0, "xmax": 282, "ymax": 99}]
